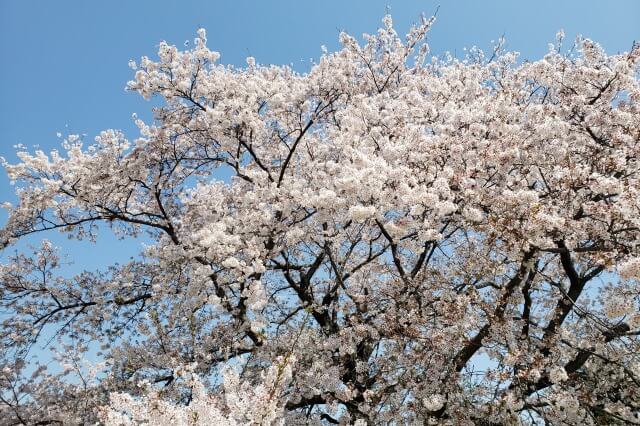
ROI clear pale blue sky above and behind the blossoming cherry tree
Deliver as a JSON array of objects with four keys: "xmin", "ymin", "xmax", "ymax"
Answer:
[{"xmin": 0, "ymin": 0, "xmax": 640, "ymax": 272}]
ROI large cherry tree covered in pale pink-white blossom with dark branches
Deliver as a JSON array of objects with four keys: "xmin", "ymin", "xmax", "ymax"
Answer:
[{"xmin": 0, "ymin": 17, "xmax": 640, "ymax": 425}]
